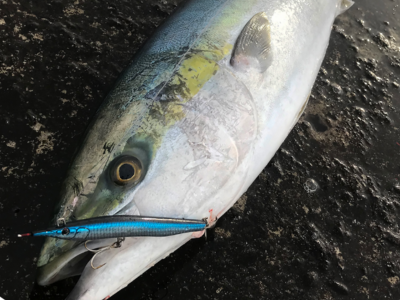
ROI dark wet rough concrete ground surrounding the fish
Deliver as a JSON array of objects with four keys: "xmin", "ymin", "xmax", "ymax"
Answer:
[{"xmin": 0, "ymin": 0, "xmax": 400, "ymax": 300}]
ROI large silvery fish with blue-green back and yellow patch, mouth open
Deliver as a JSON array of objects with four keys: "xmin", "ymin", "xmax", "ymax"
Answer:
[{"xmin": 37, "ymin": 0, "xmax": 353, "ymax": 300}]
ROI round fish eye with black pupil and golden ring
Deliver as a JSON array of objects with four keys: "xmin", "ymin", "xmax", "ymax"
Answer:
[{"xmin": 111, "ymin": 156, "xmax": 142, "ymax": 185}]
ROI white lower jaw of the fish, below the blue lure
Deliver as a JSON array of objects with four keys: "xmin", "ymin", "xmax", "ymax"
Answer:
[{"xmin": 67, "ymin": 237, "xmax": 191, "ymax": 300}]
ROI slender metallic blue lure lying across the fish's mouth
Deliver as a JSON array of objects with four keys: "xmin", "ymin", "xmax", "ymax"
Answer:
[{"xmin": 18, "ymin": 216, "xmax": 207, "ymax": 241}]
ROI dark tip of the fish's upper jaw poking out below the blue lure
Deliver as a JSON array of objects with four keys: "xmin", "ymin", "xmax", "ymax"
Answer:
[{"xmin": 37, "ymin": 239, "xmax": 115, "ymax": 286}]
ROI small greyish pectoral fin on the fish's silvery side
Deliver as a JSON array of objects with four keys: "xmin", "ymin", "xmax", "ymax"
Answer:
[{"xmin": 231, "ymin": 12, "xmax": 272, "ymax": 73}]
